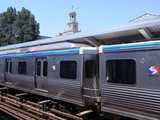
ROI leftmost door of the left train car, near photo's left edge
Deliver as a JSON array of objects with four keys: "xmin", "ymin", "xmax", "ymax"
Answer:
[{"xmin": 5, "ymin": 59, "xmax": 12, "ymax": 83}]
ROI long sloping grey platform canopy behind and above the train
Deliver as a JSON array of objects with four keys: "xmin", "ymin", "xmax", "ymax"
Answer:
[{"xmin": 0, "ymin": 19, "xmax": 160, "ymax": 51}]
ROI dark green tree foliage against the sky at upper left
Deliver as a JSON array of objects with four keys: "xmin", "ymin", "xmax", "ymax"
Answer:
[{"xmin": 0, "ymin": 7, "xmax": 39, "ymax": 45}]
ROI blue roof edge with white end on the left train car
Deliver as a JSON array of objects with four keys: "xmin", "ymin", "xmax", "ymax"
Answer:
[{"xmin": 0, "ymin": 47, "xmax": 98, "ymax": 58}]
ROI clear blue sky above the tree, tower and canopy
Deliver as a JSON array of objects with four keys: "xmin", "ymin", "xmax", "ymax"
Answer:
[{"xmin": 0, "ymin": 0, "xmax": 160, "ymax": 36}]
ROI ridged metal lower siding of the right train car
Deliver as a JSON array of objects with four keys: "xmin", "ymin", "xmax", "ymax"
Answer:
[{"xmin": 102, "ymin": 84, "xmax": 160, "ymax": 115}]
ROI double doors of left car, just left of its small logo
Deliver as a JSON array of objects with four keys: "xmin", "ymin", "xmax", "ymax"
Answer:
[{"xmin": 35, "ymin": 58, "xmax": 48, "ymax": 90}]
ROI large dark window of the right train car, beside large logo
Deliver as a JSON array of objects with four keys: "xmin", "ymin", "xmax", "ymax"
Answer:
[{"xmin": 106, "ymin": 59, "xmax": 136, "ymax": 84}]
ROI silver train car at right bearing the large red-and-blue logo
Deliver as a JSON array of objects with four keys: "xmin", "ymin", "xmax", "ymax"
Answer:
[{"xmin": 99, "ymin": 41, "xmax": 160, "ymax": 120}]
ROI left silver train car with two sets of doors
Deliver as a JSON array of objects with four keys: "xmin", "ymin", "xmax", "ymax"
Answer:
[{"xmin": 0, "ymin": 43, "xmax": 98, "ymax": 106}]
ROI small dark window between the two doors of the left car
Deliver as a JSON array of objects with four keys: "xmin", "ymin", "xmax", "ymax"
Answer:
[{"xmin": 18, "ymin": 62, "xmax": 27, "ymax": 74}]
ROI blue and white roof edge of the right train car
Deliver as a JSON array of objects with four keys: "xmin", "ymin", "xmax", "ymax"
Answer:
[{"xmin": 99, "ymin": 40, "xmax": 160, "ymax": 53}]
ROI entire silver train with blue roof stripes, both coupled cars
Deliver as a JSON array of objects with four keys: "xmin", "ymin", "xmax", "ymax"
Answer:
[{"xmin": 0, "ymin": 18, "xmax": 160, "ymax": 120}]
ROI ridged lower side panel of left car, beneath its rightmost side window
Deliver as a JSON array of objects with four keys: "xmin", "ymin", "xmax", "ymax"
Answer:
[{"xmin": 48, "ymin": 80, "xmax": 83, "ymax": 105}]
